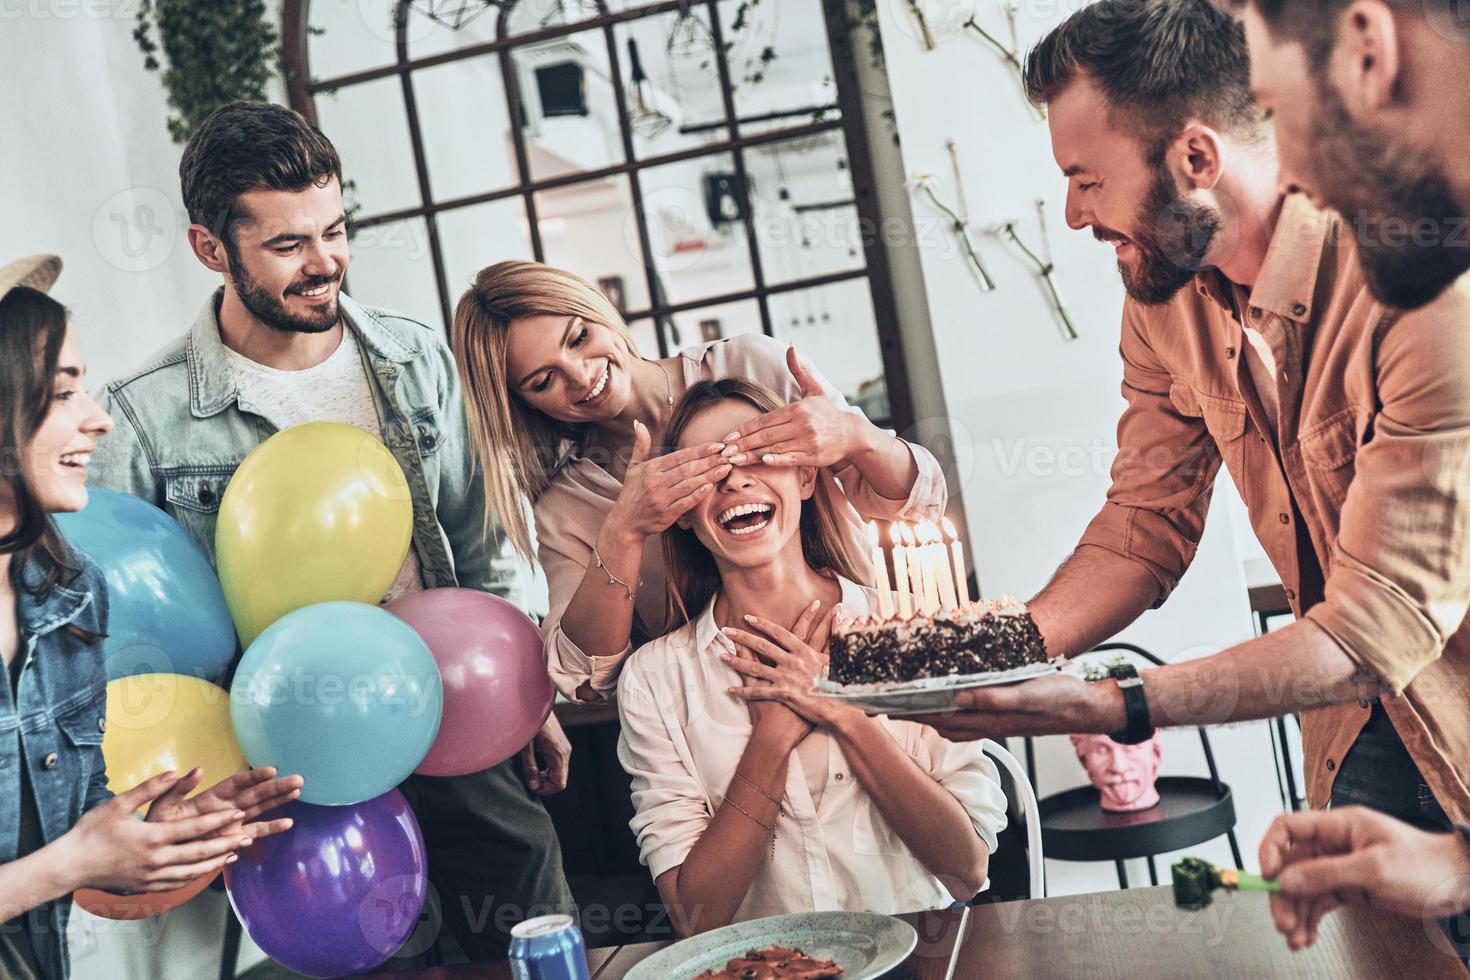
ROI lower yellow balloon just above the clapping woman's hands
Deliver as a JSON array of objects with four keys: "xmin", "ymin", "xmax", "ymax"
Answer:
[{"xmin": 101, "ymin": 674, "xmax": 250, "ymax": 795}]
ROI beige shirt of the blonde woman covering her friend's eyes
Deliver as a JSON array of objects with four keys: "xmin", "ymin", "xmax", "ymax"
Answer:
[{"xmin": 534, "ymin": 334, "xmax": 947, "ymax": 699}]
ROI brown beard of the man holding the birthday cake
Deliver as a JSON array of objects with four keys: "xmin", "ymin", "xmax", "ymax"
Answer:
[{"xmin": 1092, "ymin": 165, "xmax": 1225, "ymax": 306}]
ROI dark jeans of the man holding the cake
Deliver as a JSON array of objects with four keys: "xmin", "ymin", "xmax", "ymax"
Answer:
[{"xmin": 1332, "ymin": 702, "xmax": 1470, "ymax": 962}]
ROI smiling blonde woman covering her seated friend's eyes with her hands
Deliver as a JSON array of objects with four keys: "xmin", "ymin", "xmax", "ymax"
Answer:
[{"xmin": 453, "ymin": 262, "xmax": 945, "ymax": 701}]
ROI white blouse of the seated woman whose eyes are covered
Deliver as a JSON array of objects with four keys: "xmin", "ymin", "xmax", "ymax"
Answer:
[{"xmin": 617, "ymin": 579, "xmax": 1005, "ymax": 921}]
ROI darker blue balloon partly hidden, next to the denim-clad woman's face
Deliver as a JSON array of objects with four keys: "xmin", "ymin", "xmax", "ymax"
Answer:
[{"xmin": 56, "ymin": 488, "xmax": 237, "ymax": 680}]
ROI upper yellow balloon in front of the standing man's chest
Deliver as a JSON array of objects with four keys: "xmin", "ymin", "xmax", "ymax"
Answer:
[{"xmin": 215, "ymin": 422, "xmax": 413, "ymax": 646}]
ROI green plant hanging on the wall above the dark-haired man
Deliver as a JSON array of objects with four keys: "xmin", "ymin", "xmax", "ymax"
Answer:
[{"xmin": 132, "ymin": 0, "xmax": 281, "ymax": 143}]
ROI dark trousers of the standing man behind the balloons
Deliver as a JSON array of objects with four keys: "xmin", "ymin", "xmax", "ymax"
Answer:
[{"xmin": 391, "ymin": 760, "xmax": 576, "ymax": 965}]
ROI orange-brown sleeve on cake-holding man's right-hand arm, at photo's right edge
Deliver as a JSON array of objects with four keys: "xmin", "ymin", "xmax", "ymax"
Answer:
[{"xmin": 1307, "ymin": 295, "xmax": 1470, "ymax": 693}]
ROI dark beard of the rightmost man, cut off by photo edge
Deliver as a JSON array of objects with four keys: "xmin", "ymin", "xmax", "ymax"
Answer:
[{"xmin": 1308, "ymin": 85, "xmax": 1470, "ymax": 310}]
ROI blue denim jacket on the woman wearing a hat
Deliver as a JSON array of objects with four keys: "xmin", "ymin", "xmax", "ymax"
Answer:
[{"xmin": 0, "ymin": 555, "xmax": 112, "ymax": 977}]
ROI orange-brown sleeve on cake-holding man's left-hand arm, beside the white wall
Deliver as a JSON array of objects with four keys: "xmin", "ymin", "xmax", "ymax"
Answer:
[{"xmin": 1078, "ymin": 301, "xmax": 1220, "ymax": 607}]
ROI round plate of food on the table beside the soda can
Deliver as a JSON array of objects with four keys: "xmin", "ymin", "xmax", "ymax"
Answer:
[{"xmin": 625, "ymin": 912, "xmax": 919, "ymax": 980}]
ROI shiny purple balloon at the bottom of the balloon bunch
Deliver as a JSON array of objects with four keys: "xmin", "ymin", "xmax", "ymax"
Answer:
[{"xmin": 225, "ymin": 789, "xmax": 429, "ymax": 977}]
